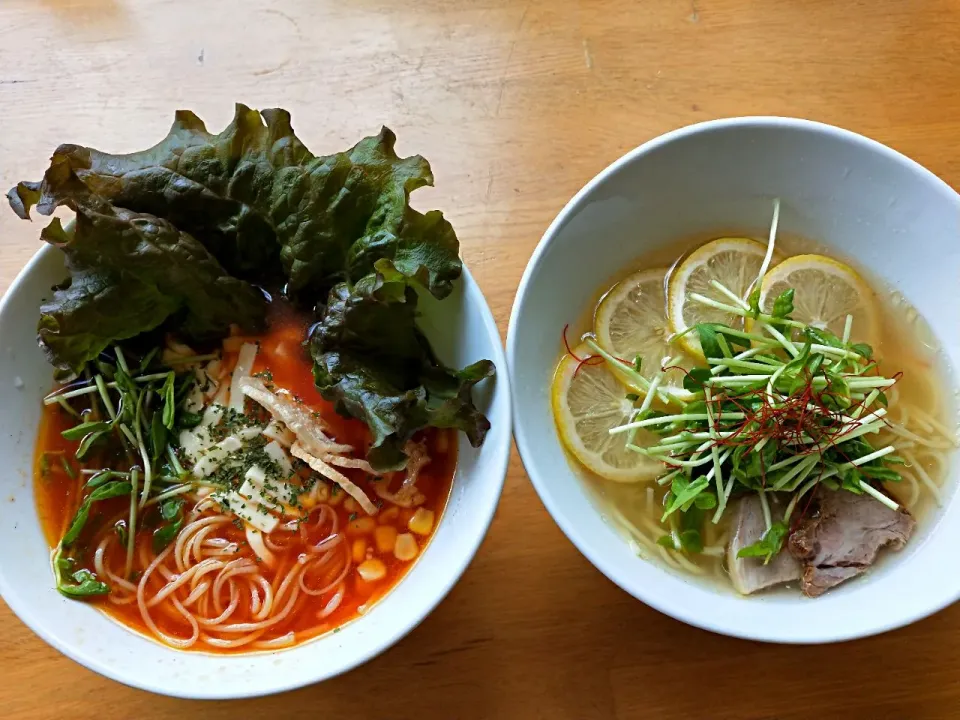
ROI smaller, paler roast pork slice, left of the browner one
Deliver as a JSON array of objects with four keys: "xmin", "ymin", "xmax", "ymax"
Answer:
[{"xmin": 727, "ymin": 495, "xmax": 801, "ymax": 595}]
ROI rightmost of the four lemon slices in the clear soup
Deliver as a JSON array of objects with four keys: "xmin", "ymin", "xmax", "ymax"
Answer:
[{"xmin": 760, "ymin": 255, "xmax": 880, "ymax": 344}]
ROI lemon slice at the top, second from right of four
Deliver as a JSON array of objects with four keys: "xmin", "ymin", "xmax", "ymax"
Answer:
[{"xmin": 667, "ymin": 238, "xmax": 767, "ymax": 359}]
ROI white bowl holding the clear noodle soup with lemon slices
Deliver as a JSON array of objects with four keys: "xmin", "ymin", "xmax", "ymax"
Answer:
[{"xmin": 507, "ymin": 118, "xmax": 960, "ymax": 643}]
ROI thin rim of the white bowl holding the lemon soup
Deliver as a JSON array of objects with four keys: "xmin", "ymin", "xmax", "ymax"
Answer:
[{"xmin": 507, "ymin": 115, "xmax": 960, "ymax": 645}]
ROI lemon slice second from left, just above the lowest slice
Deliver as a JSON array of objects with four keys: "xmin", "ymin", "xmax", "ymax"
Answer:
[{"xmin": 593, "ymin": 268, "xmax": 693, "ymax": 398}]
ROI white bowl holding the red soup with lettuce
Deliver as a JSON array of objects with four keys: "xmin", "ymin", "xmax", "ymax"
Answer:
[{"xmin": 0, "ymin": 247, "xmax": 510, "ymax": 698}]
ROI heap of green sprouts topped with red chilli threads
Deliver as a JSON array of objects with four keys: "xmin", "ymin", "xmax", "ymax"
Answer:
[{"xmin": 591, "ymin": 270, "xmax": 903, "ymax": 562}]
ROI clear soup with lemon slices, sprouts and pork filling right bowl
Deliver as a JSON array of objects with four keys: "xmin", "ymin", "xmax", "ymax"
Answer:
[{"xmin": 553, "ymin": 212, "xmax": 956, "ymax": 597}]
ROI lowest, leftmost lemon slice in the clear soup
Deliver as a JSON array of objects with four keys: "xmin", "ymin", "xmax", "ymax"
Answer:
[{"xmin": 551, "ymin": 344, "xmax": 663, "ymax": 483}]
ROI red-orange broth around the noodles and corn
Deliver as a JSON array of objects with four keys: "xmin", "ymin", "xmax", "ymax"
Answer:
[{"xmin": 34, "ymin": 303, "xmax": 457, "ymax": 653}]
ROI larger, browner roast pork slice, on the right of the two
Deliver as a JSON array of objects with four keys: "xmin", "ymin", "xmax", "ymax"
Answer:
[{"xmin": 788, "ymin": 488, "xmax": 916, "ymax": 597}]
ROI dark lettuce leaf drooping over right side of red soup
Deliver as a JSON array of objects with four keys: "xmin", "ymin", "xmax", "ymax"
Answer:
[{"xmin": 309, "ymin": 272, "xmax": 494, "ymax": 472}]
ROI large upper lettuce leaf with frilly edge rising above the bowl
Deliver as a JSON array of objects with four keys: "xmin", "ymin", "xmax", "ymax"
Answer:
[{"xmin": 11, "ymin": 104, "xmax": 461, "ymax": 302}]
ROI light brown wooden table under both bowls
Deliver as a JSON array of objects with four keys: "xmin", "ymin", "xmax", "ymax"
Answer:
[{"xmin": 0, "ymin": 0, "xmax": 960, "ymax": 720}]
